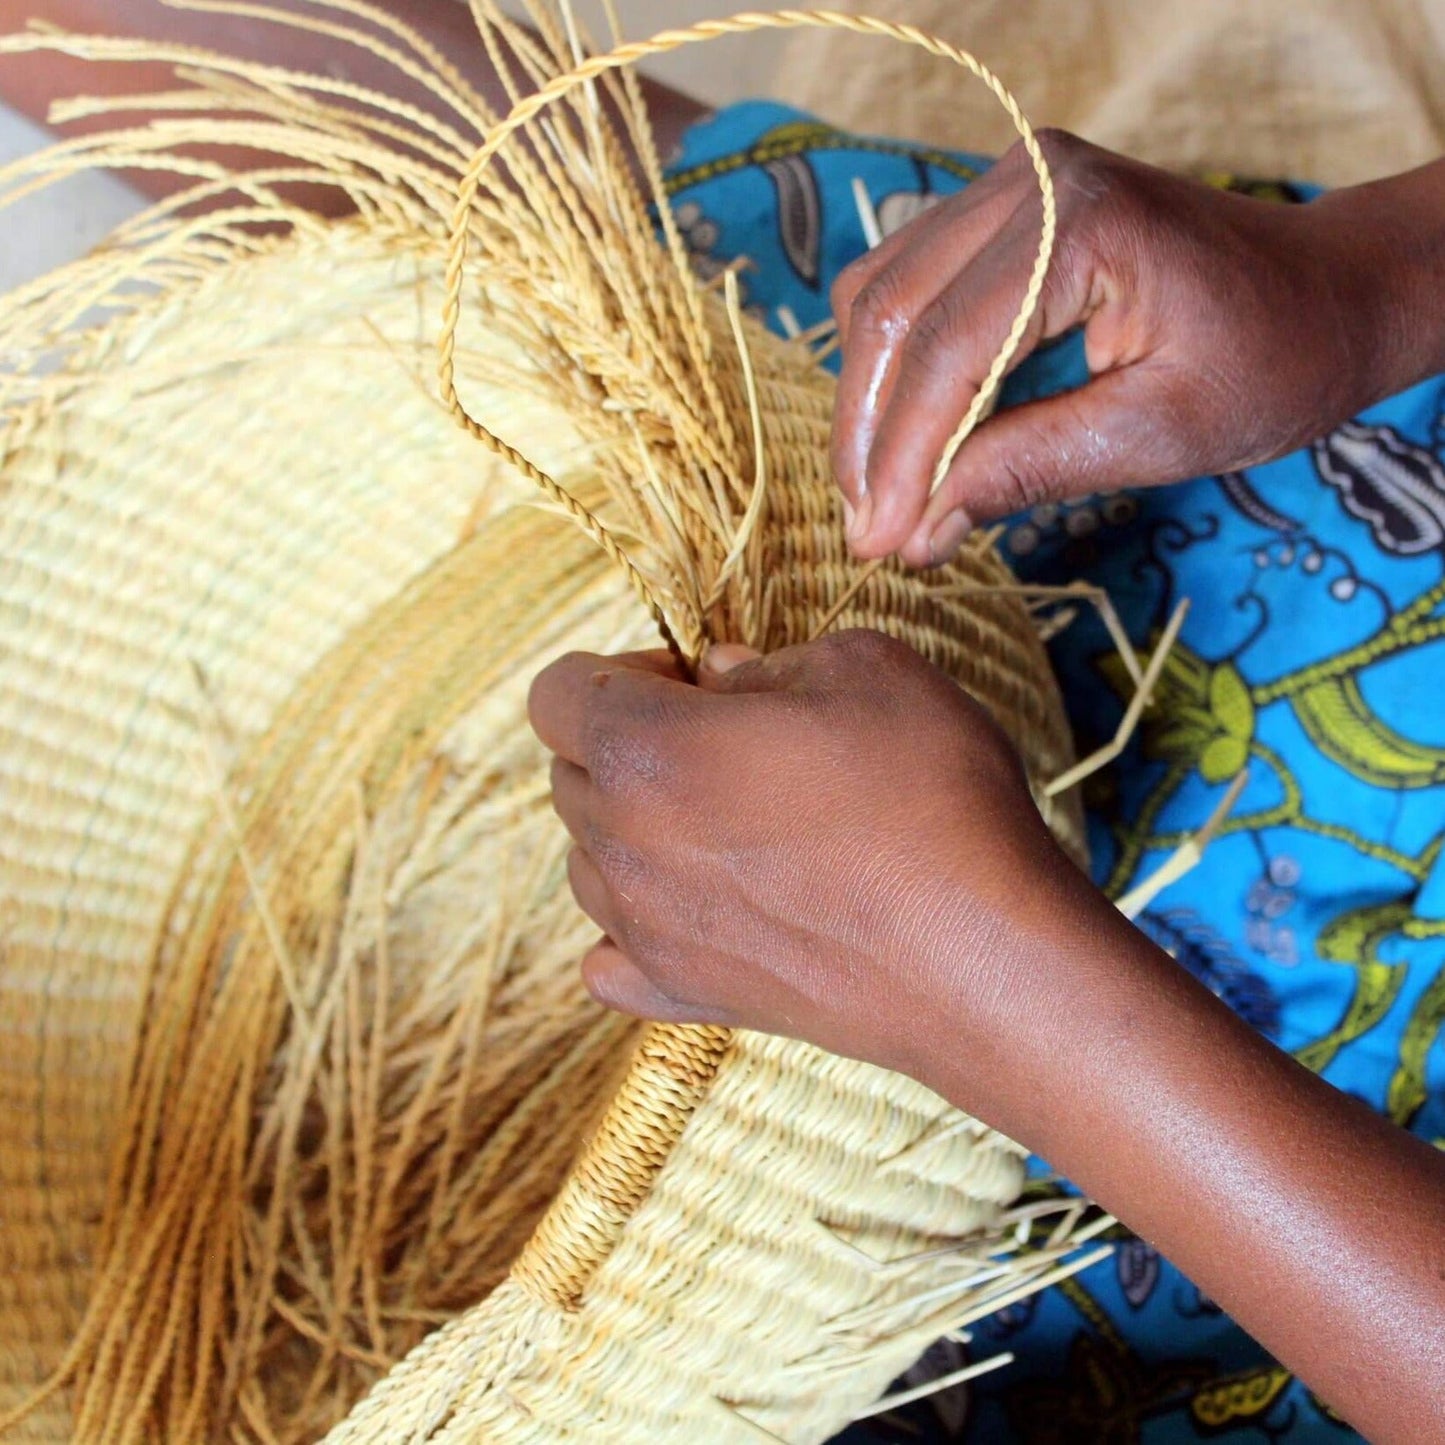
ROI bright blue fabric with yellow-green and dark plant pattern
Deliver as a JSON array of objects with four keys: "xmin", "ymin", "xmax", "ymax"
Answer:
[{"xmin": 670, "ymin": 103, "xmax": 1445, "ymax": 1445}]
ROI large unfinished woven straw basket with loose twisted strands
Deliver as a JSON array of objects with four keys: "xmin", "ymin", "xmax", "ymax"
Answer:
[{"xmin": 0, "ymin": 0, "xmax": 1082, "ymax": 1445}]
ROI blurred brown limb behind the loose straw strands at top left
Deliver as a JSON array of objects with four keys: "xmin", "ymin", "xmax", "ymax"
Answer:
[{"xmin": 0, "ymin": 0, "xmax": 702, "ymax": 210}]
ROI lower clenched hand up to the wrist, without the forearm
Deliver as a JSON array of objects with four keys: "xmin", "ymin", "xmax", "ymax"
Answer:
[{"xmin": 532, "ymin": 631, "xmax": 1117, "ymax": 1129}]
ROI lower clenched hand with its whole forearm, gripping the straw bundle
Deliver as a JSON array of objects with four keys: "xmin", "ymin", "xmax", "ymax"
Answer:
[{"xmin": 532, "ymin": 633, "xmax": 1445, "ymax": 1445}]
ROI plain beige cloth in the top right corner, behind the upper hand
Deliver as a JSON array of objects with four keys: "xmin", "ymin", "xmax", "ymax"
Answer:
[{"xmin": 773, "ymin": 0, "xmax": 1445, "ymax": 185}]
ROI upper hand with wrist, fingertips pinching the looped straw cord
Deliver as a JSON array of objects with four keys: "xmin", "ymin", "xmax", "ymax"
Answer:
[{"xmin": 832, "ymin": 133, "xmax": 1445, "ymax": 566}]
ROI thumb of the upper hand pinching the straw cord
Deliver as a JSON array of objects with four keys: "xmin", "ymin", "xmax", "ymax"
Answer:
[{"xmin": 900, "ymin": 366, "xmax": 1194, "ymax": 566}]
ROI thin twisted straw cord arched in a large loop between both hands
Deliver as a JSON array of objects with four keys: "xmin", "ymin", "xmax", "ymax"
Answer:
[{"xmin": 439, "ymin": 10, "xmax": 1058, "ymax": 644}]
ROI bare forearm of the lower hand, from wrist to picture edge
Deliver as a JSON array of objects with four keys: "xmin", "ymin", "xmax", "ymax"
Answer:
[{"xmin": 924, "ymin": 884, "xmax": 1445, "ymax": 1445}]
